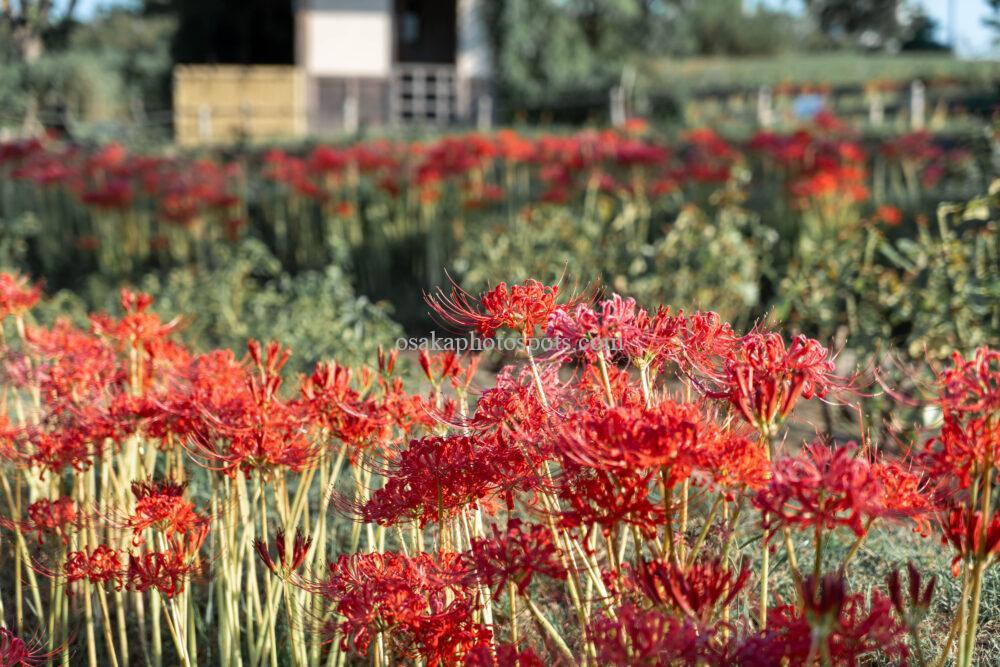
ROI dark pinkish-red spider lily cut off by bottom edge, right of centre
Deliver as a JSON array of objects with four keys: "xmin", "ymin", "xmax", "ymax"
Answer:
[{"xmin": 587, "ymin": 604, "xmax": 715, "ymax": 667}]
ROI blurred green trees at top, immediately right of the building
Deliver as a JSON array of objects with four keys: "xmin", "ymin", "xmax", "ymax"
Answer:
[{"xmin": 486, "ymin": 0, "xmax": 801, "ymax": 111}]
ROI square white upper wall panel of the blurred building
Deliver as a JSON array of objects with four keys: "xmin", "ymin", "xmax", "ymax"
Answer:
[{"xmin": 296, "ymin": 0, "xmax": 392, "ymax": 77}]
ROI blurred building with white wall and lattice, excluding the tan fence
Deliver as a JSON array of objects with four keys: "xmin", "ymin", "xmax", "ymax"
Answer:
[{"xmin": 295, "ymin": 0, "xmax": 490, "ymax": 132}]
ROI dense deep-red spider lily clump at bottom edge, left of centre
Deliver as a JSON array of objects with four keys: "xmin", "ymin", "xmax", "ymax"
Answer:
[{"xmin": 317, "ymin": 553, "xmax": 489, "ymax": 665}]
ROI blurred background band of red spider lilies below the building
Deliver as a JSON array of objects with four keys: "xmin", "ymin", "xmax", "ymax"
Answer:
[{"xmin": 0, "ymin": 125, "xmax": 977, "ymax": 286}]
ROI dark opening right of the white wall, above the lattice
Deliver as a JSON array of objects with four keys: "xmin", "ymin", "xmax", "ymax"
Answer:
[{"xmin": 395, "ymin": 0, "xmax": 458, "ymax": 65}]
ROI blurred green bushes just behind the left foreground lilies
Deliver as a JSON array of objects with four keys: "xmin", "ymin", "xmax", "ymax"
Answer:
[{"xmin": 33, "ymin": 241, "xmax": 402, "ymax": 371}]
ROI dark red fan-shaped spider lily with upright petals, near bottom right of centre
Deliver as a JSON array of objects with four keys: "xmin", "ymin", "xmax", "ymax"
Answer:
[{"xmin": 631, "ymin": 559, "xmax": 750, "ymax": 624}]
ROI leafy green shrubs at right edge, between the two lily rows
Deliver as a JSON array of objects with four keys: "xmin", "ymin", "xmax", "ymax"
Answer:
[{"xmin": 775, "ymin": 182, "xmax": 1000, "ymax": 362}]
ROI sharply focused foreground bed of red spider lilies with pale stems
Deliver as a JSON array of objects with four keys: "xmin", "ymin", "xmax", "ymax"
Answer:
[{"xmin": 0, "ymin": 276, "xmax": 1000, "ymax": 667}]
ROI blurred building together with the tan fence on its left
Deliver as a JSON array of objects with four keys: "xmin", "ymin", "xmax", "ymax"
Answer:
[{"xmin": 174, "ymin": 0, "xmax": 492, "ymax": 145}]
